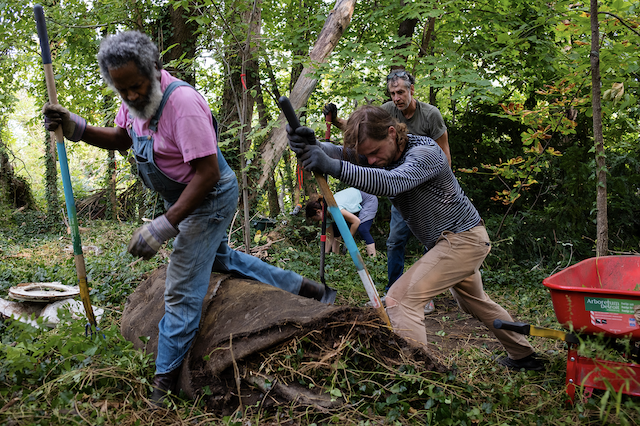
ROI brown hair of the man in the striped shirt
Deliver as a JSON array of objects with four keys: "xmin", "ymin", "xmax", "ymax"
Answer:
[{"xmin": 343, "ymin": 105, "xmax": 407, "ymax": 157}]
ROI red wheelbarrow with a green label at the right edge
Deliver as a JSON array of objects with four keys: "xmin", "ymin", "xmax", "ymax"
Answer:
[{"xmin": 494, "ymin": 256, "xmax": 640, "ymax": 399}]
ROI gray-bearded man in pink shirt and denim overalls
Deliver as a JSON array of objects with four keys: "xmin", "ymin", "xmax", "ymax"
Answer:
[{"xmin": 43, "ymin": 31, "xmax": 336, "ymax": 404}]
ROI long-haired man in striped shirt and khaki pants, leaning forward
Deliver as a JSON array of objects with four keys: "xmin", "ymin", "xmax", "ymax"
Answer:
[{"xmin": 288, "ymin": 105, "xmax": 544, "ymax": 370}]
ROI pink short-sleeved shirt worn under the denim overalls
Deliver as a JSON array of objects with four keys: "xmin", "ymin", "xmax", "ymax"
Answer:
[{"xmin": 115, "ymin": 70, "xmax": 218, "ymax": 183}]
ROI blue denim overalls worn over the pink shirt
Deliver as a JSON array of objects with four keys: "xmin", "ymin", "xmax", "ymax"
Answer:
[{"xmin": 128, "ymin": 81, "xmax": 302, "ymax": 374}]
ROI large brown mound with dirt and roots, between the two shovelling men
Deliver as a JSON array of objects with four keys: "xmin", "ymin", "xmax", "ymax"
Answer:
[{"xmin": 121, "ymin": 267, "xmax": 446, "ymax": 414}]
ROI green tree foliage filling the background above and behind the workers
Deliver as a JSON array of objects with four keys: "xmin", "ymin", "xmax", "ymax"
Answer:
[{"xmin": 0, "ymin": 0, "xmax": 640, "ymax": 262}]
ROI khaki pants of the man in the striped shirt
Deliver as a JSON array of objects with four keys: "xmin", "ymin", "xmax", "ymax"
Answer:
[{"xmin": 386, "ymin": 225, "xmax": 534, "ymax": 359}]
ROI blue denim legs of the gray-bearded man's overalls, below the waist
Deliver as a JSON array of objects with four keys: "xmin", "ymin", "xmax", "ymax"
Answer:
[{"xmin": 156, "ymin": 176, "xmax": 302, "ymax": 374}]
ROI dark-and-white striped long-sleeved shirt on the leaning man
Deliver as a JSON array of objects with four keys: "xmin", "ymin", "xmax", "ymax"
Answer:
[{"xmin": 323, "ymin": 135, "xmax": 480, "ymax": 249}]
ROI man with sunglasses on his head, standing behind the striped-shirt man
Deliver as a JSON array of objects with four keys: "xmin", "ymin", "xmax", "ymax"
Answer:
[{"xmin": 322, "ymin": 69, "xmax": 451, "ymax": 314}]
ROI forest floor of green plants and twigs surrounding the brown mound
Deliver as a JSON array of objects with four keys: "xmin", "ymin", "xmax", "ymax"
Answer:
[{"xmin": 0, "ymin": 212, "xmax": 640, "ymax": 426}]
